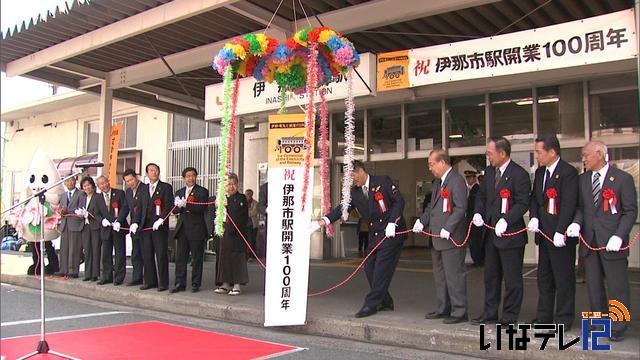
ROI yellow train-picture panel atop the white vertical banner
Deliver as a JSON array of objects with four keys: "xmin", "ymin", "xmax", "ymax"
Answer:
[{"xmin": 269, "ymin": 114, "xmax": 314, "ymax": 168}]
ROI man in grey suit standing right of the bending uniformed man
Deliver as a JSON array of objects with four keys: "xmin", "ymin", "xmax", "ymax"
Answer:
[{"xmin": 413, "ymin": 149, "xmax": 468, "ymax": 324}]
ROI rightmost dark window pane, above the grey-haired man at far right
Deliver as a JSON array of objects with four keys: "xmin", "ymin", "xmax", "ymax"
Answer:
[{"xmin": 589, "ymin": 89, "xmax": 640, "ymax": 137}]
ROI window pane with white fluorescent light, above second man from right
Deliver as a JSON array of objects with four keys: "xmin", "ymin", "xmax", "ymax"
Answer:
[{"xmin": 538, "ymin": 83, "xmax": 584, "ymax": 140}]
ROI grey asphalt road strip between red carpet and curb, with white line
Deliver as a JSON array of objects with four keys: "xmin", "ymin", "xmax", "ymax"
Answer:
[{"xmin": 0, "ymin": 284, "xmax": 480, "ymax": 360}]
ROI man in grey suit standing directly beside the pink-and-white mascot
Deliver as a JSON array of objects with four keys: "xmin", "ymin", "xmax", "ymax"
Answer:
[{"xmin": 56, "ymin": 176, "xmax": 84, "ymax": 278}]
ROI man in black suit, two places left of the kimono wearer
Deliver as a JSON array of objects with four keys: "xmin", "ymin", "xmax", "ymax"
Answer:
[{"xmin": 140, "ymin": 163, "xmax": 173, "ymax": 291}]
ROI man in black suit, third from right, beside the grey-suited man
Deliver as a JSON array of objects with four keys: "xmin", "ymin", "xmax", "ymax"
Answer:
[{"xmin": 472, "ymin": 137, "xmax": 531, "ymax": 325}]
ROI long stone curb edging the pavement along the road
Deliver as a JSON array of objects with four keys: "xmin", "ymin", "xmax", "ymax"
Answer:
[{"xmin": 0, "ymin": 274, "xmax": 640, "ymax": 360}]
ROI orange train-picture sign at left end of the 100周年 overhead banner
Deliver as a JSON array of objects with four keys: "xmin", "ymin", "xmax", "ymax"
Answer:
[{"xmin": 376, "ymin": 50, "xmax": 409, "ymax": 91}]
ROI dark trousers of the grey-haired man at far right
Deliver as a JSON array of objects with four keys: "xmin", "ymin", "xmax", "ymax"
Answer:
[{"xmin": 583, "ymin": 251, "xmax": 633, "ymax": 331}]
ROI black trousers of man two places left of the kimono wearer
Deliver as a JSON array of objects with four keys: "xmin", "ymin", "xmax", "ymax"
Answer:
[{"xmin": 142, "ymin": 228, "xmax": 169, "ymax": 288}]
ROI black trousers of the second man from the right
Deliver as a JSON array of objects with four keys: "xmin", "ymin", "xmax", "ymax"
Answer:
[{"xmin": 536, "ymin": 239, "xmax": 576, "ymax": 327}]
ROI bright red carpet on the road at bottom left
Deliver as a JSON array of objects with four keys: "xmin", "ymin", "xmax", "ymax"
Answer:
[{"xmin": 0, "ymin": 321, "xmax": 301, "ymax": 360}]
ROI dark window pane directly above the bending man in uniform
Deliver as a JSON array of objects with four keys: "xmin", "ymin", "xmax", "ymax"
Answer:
[{"xmin": 369, "ymin": 105, "xmax": 402, "ymax": 154}]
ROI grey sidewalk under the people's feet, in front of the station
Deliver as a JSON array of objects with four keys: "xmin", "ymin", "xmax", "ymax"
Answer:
[{"xmin": 0, "ymin": 252, "xmax": 640, "ymax": 360}]
